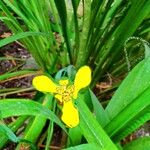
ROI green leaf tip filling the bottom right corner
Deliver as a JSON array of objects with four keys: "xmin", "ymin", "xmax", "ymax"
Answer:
[{"xmin": 123, "ymin": 137, "xmax": 150, "ymax": 150}]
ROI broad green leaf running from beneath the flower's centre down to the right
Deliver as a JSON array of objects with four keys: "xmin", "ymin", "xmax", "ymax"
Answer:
[{"xmin": 76, "ymin": 95, "xmax": 117, "ymax": 150}]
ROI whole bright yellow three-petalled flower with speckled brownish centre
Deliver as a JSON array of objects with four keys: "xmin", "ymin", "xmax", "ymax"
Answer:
[{"xmin": 32, "ymin": 66, "xmax": 91, "ymax": 128}]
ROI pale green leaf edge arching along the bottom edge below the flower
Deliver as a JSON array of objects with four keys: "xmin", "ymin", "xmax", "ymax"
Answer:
[{"xmin": 63, "ymin": 143, "xmax": 101, "ymax": 150}]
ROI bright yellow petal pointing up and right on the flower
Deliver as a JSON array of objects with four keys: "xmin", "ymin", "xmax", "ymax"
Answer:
[{"xmin": 74, "ymin": 66, "xmax": 91, "ymax": 98}]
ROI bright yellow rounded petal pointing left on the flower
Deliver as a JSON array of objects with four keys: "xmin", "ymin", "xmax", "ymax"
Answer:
[{"xmin": 32, "ymin": 75, "xmax": 57, "ymax": 93}]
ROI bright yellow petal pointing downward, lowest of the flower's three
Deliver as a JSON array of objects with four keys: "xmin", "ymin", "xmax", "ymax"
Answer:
[{"xmin": 61, "ymin": 101, "xmax": 79, "ymax": 128}]
